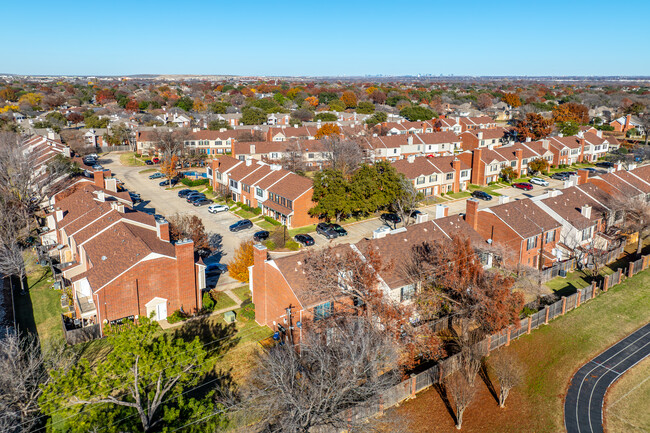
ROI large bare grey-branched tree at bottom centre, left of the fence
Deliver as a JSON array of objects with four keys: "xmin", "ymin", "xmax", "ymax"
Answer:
[{"xmin": 243, "ymin": 317, "xmax": 398, "ymax": 433}]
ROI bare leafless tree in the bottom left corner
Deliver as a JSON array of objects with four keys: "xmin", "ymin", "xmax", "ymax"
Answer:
[{"xmin": 0, "ymin": 332, "xmax": 75, "ymax": 433}]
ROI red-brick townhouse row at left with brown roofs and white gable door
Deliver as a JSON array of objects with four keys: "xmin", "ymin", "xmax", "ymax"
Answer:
[{"xmin": 41, "ymin": 170, "xmax": 205, "ymax": 331}]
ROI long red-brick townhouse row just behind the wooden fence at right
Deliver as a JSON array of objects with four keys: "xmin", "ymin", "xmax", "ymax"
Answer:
[{"xmin": 250, "ymin": 166, "xmax": 650, "ymax": 332}]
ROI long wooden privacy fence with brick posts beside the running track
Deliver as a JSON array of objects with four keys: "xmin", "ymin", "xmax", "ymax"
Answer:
[{"xmin": 324, "ymin": 253, "xmax": 650, "ymax": 426}]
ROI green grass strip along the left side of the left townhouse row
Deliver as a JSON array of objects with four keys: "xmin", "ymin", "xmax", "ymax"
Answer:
[{"xmin": 14, "ymin": 253, "xmax": 63, "ymax": 341}]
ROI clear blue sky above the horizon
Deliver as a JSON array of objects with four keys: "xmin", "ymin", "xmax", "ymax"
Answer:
[{"xmin": 5, "ymin": 0, "xmax": 650, "ymax": 75}]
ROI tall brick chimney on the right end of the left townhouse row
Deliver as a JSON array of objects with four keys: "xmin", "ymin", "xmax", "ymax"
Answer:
[{"xmin": 175, "ymin": 239, "xmax": 200, "ymax": 314}]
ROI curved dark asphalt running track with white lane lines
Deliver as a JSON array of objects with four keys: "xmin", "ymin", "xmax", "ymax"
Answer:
[{"xmin": 564, "ymin": 323, "xmax": 650, "ymax": 433}]
